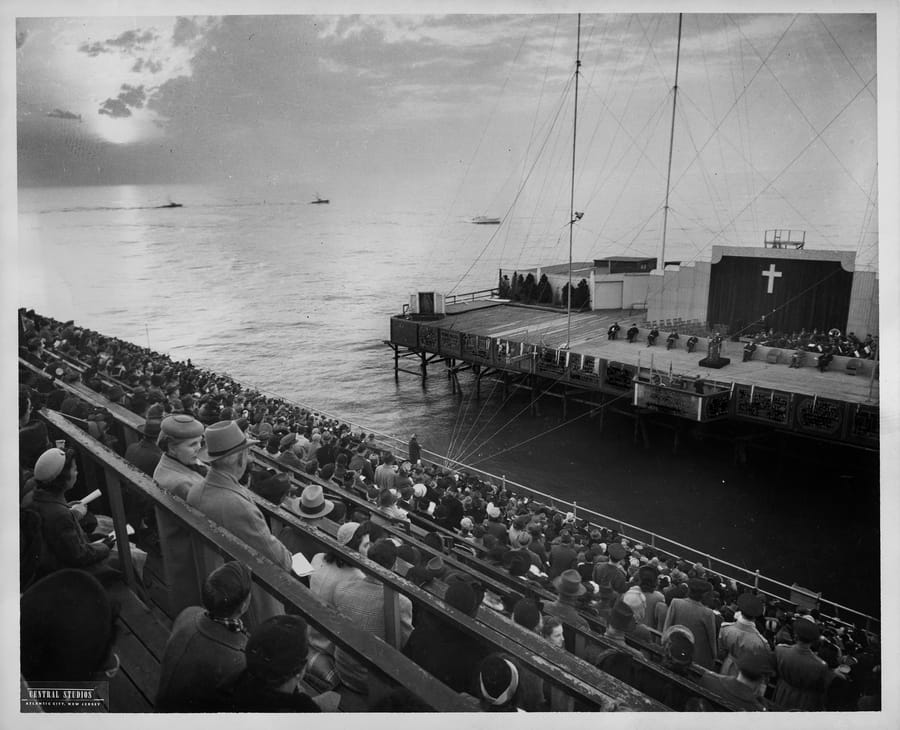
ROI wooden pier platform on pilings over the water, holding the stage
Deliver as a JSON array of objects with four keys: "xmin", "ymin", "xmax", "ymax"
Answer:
[{"xmin": 385, "ymin": 299, "xmax": 879, "ymax": 450}]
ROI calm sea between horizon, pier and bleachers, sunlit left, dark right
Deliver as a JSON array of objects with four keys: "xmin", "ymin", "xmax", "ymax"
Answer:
[{"xmin": 18, "ymin": 186, "xmax": 880, "ymax": 611}]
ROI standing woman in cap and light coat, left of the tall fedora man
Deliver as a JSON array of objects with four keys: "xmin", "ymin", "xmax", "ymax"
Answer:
[{"xmin": 153, "ymin": 413, "xmax": 206, "ymax": 615}]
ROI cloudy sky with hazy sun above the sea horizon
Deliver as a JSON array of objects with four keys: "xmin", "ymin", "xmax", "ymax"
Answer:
[{"xmin": 3, "ymin": 3, "xmax": 896, "ymax": 270}]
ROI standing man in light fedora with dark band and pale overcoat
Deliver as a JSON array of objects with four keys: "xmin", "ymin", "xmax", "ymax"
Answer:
[{"xmin": 187, "ymin": 421, "xmax": 291, "ymax": 629}]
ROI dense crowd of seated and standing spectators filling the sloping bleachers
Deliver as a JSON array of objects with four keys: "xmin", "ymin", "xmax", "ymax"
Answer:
[{"xmin": 19, "ymin": 312, "xmax": 880, "ymax": 711}]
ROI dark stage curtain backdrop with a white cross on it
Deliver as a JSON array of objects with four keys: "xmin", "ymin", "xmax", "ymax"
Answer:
[{"xmin": 708, "ymin": 256, "xmax": 853, "ymax": 334}]
